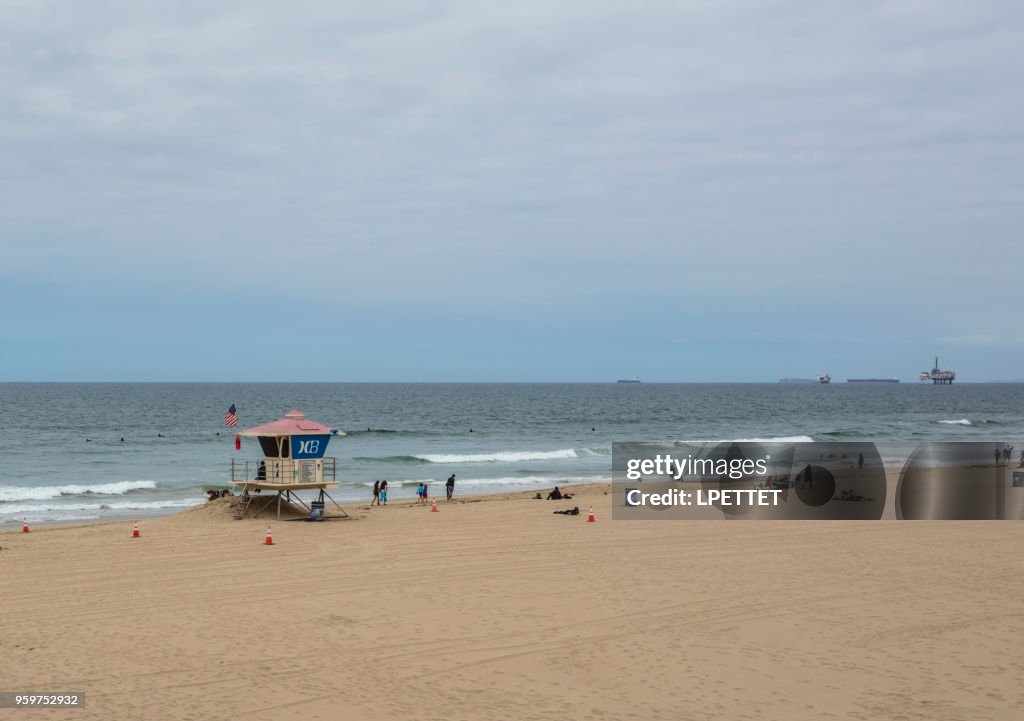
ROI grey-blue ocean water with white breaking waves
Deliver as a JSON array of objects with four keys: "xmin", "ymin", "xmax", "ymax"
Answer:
[{"xmin": 0, "ymin": 383, "xmax": 1024, "ymax": 527}]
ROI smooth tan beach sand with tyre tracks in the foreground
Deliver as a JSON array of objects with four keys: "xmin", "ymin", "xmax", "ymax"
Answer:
[{"xmin": 0, "ymin": 486, "xmax": 1024, "ymax": 721}]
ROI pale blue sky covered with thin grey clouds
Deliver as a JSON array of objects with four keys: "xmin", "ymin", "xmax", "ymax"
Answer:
[{"xmin": 0, "ymin": 0, "xmax": 1024, "ymax": 382}]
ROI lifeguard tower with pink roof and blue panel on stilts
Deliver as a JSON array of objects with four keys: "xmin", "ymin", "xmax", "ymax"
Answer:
[{"xmin": 231, "ymin": 411, "xmax": 348, "ymax": 519}]
